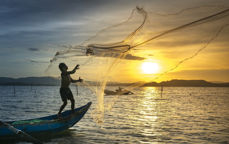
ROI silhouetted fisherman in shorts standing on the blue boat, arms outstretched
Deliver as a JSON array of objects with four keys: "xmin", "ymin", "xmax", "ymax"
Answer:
[{"xmin": 58, "ymin": 63, "xmax": 83, "ymax": 117}]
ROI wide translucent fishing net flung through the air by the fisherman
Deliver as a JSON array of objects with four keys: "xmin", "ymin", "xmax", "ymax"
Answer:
[{"xmin": 45, "ymin": 6, "xmax": 229, "ymax": 122}]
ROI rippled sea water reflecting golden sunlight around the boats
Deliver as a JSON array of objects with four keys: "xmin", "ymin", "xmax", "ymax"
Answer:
[{"xmin": 0, "ymin": 86, "xmax": 229, "ymax": 144}]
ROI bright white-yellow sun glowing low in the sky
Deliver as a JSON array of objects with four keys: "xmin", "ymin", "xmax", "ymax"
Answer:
[{"xmin": 141, "ymin": 62, "xmax": 159, "ymax": 74}]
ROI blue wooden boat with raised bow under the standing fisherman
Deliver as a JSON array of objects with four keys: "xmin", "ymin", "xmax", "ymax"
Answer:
[{"xmin": 0, "ymin": 102, "xmax": 91, "ymax": 139}]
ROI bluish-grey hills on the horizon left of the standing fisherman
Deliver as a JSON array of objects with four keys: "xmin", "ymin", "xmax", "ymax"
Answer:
[{"xmin": 0, "ymin": 77, "xmax": 60, "ymax": 85}]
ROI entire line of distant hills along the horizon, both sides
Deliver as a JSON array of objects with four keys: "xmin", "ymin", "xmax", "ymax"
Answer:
[{"xmin": 0, "ymin": 77, "xmax": 229, "ymax": 87}]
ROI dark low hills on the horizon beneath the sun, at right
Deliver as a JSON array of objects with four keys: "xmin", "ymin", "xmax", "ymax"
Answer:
[{"xmin": 143, "ymin": 79, "xmax": 229, "ymax": 87}]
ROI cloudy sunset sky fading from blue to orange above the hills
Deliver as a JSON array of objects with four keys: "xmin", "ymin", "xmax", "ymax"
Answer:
[{"xmin": 0, "ymin": 0, "xmax": 229, "ymax": 82}]
